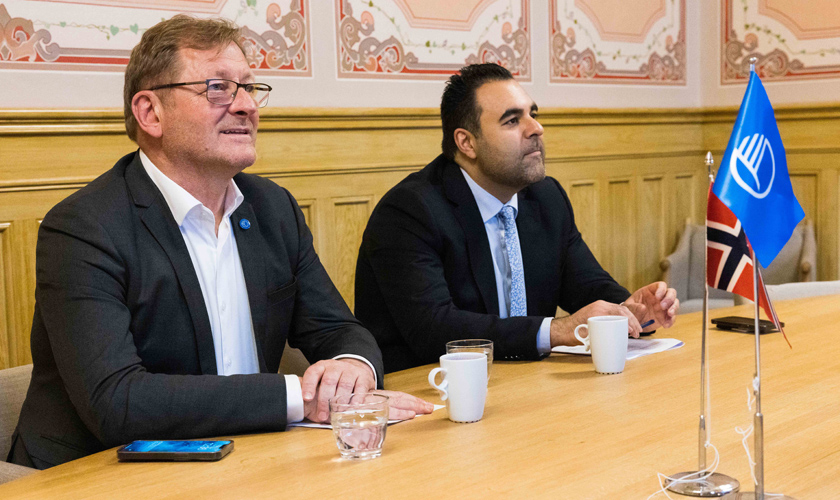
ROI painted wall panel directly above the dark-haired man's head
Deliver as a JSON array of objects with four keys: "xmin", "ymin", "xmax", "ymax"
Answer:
[{"xmin": 335, "ymin": 0, "xmax": 531, "ymax": 80}]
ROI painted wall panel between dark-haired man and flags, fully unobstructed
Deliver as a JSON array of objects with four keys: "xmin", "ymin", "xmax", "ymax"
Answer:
[{"xmin": 549, "ymin": 0, "xmax": 686, "ymax": 85}]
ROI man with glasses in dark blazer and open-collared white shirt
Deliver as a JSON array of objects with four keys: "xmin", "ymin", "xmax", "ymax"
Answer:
[{"xmin": 10, "ymin": 16, "xmax": 431, "ymax": 469}]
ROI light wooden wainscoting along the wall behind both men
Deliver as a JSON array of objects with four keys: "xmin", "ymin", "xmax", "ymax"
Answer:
[{"xmin": 0, "ymin": 104, "xmax": 840, "ymax": 368}]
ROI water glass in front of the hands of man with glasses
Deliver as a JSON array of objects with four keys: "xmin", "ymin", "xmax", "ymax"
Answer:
[{"xmin": 330, "ymin": 393, "xmax": 388, "ymax": 460}]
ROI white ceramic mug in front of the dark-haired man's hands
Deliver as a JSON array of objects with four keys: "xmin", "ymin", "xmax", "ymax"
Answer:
[{"xmin": 575, "ymin": 316, "xmax": 627, "ymax": 373}]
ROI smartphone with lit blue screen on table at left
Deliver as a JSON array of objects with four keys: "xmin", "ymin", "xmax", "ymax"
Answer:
[{"xmin": 117, "ymin": 440, "xmax": 233, "ymax": 462}]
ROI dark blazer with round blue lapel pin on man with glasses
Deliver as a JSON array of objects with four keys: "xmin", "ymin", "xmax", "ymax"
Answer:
[{"xmin": 13, "ymin": 153, "xmax": 382, "ymax": 468}]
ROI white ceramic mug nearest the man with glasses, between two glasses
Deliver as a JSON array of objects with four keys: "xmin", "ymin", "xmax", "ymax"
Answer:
[{"xmin": 429, "ymin": 352, "xmax": 487, "ymax": 422}]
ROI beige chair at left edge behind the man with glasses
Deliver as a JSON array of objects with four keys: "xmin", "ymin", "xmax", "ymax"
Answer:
[{"xmin": 0, "ymin": 365, "xmax": 38, "ymax": 484}]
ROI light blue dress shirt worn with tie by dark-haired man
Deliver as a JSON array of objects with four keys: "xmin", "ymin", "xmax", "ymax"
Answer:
[{"xmin": 461, "ymin": 168, "xmax": 553, "ymax": 354}]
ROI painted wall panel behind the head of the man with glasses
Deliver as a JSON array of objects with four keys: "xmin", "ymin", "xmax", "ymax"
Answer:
[{"xmin": 0, "ymin": 0, "xmax": 312, "ymax": 76}]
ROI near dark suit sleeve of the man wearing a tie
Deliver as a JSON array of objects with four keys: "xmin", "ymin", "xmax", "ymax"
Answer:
[{"xmin": 357, "ymin": 190, "xmax": 544, "ymax": 363}]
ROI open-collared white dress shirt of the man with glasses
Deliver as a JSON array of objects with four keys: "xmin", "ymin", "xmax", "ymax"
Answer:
[{"xmin": 140, "ymin": 151, "xmax": 376, "ymax": 422}]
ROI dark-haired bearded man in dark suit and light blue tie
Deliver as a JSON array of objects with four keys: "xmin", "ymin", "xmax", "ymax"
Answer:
[{"xmin": 356, "ymin": 64, "xmax": 679, "ymax": 372}]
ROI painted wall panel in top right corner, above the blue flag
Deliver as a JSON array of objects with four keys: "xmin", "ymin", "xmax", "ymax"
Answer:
[{"xmin": 721, "ymin": 0, "xmax": 840, "ymax": 84}]
